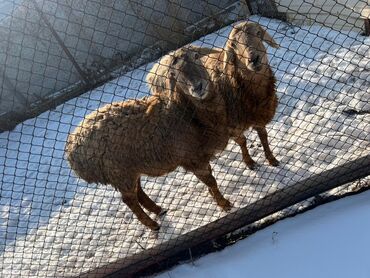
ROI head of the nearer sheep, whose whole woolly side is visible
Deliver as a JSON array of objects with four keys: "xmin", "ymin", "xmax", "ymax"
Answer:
[{"xmin": 168, "ymin": 47, "xmax": 210, "ymax": 101}]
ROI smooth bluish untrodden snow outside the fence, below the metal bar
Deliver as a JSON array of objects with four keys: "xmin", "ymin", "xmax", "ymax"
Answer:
[{"xmin": 156, "ymin": 191, "xmax": 370, "ymax": 278}]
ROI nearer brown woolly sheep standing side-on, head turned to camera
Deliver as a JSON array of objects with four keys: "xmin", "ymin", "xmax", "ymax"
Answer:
[{"xmin": 65, "ymin": 49, "xmax": 232, "ymax": 230}]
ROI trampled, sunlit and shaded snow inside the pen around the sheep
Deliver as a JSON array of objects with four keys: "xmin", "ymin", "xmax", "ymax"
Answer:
[{"xmin": 0, "ymin": 16, "xmax": 370, "ymax": 277}]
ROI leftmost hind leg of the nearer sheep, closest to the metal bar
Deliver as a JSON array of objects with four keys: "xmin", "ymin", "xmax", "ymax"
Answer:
[{"xmin": 119, "ymin": 189, "xmax": 159, "ymax": 231}]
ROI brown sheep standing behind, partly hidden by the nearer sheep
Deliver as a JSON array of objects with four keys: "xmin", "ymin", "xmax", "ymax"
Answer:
[{"xmin": 147, "ymin": 22, "xmax": 279, "ymax": 169}]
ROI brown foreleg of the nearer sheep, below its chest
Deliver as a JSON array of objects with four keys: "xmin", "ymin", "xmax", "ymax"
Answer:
[{"xmin": 192, "ymin": 164, "xmax": 232, "ymax": 211}]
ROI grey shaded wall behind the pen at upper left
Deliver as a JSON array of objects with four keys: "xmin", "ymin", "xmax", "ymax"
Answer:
[{"xmin": 0, "ymin": 0, "xmax": 244, "ymax": 118}]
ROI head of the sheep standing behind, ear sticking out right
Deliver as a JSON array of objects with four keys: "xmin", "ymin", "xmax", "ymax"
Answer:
[{"xmin": 224, "ymin": 22, "xmax": 279, "ymax": 72}]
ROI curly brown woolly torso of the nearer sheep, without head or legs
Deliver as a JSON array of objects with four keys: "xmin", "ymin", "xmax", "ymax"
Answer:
[{"xmin": 66, "ymin": 93, "xmax": 228, "ymax": 185}]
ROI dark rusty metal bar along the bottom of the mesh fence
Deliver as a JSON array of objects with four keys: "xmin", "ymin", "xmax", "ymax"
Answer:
[{"xmin": 79, "ymin": 154, "xmax": 370, "ymax": 278}]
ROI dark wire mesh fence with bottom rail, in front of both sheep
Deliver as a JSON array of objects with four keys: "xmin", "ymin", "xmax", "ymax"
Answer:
[{"xmin": 0, "ymin": 0, "xmax": 370, "ymax": 277}]
